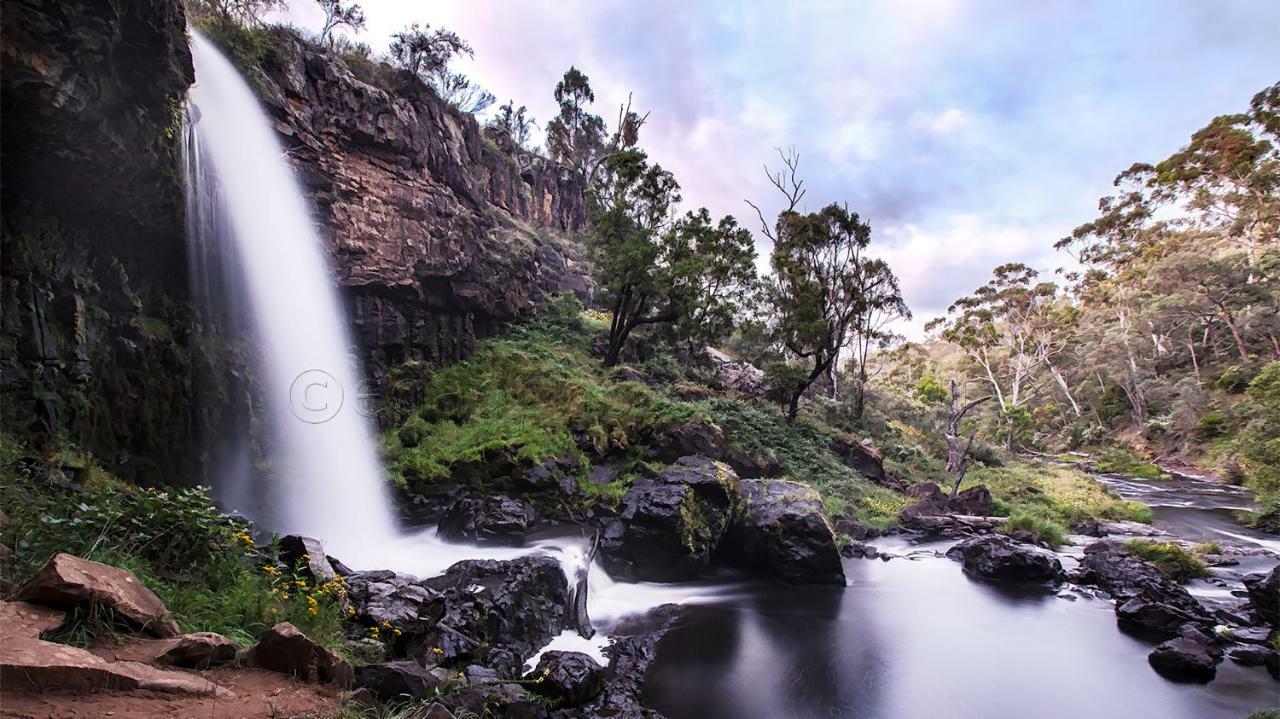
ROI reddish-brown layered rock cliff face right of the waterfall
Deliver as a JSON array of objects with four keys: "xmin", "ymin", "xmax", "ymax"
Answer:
[{"xmin": 248, "ymin": 32, "xmax": 589, "ymax": 379}]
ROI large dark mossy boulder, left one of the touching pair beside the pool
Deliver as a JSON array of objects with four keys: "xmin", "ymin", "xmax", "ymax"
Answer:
[{"xmin": 599, "ymin": 457, "xmax": 739, "ymax": 582}]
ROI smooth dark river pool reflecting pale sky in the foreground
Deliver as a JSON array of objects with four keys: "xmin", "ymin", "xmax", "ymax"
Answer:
[{"xmin": 645, "ymin": 542, "xmax": 1277, "ymax": 719}]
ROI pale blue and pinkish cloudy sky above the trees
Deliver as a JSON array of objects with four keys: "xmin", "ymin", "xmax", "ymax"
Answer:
[{"xmin": 277, "ymin": 0, "xmax": 1280, "ymax": 339}]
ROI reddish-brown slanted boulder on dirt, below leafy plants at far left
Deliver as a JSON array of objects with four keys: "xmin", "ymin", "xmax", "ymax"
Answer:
[{"xmin": 14, "ymin": 554, "xmax": 182, "ymax": 637}]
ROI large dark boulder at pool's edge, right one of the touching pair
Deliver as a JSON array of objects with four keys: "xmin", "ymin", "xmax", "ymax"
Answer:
[{"xmin": 721, "ymin": 480, "xmax": 845, "ymax": 586}]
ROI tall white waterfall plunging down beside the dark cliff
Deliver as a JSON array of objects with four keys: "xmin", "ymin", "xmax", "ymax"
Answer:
[{"xmin": 183, "ymin": 32, "xmax": 396, "ymax": 564}]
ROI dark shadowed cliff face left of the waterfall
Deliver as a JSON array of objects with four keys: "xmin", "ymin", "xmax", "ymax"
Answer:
[{"xmin": 0, "ymin": 0, "xmax": 209, "ymax": 481}]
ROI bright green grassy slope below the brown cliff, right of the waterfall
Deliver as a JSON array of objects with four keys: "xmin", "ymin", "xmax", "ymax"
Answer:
[{"xmin": 384, "ymin": 322, "xmax": 694, "ymax": 482}]
